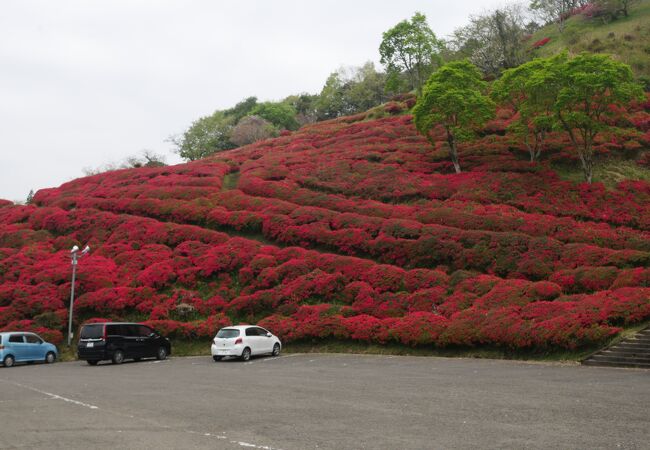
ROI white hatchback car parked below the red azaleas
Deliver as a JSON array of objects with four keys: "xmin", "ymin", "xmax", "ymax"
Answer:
[{"xmin": 212, "ymin": 325, "xmax": 282, "ymax": 361}]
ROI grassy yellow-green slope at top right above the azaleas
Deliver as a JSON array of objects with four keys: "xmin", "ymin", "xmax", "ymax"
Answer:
[{"xmin": 529, "ymin": 0, "xmax": 650, "ymax": 78}]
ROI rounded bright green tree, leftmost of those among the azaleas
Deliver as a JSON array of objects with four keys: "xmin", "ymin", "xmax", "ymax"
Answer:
[{"xmin": 413, "ymin": 60, "xmax": 495, "ymax": 173}]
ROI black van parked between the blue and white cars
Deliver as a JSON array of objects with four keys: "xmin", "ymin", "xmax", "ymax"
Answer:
[{"xmin": 77, "ymin": 322, "xmax": 172, "ymax": 366}]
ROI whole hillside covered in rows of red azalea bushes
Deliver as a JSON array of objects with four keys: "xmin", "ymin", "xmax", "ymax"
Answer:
[{"xmin": 0, "ymin": 97, "xmax": 650, "ymax": 350}]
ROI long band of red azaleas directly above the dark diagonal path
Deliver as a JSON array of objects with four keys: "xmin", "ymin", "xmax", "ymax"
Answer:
[{"xmin": 35, "ymin": 191, "xmax": 650, "ymax": 279}]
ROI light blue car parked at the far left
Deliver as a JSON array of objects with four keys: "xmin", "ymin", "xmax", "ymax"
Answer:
[{"xmin": 0, "ymin": 331, "xmax": 59, "ymax": 367}]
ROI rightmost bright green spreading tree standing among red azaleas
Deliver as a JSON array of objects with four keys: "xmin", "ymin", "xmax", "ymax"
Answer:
[{"xmin": 548, "ymin": 53, "xmax": 644, "ymax": 183}]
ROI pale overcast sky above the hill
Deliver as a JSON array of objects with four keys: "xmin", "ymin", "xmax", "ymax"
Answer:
[{"xmin": 0, "ymin": 0, "xmax": 502, "ymax": 200}]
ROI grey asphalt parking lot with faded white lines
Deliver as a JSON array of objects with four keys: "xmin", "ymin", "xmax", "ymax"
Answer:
[{"xmin": 0, "ymin": 354, "xmax": 650, "ymax": 449}]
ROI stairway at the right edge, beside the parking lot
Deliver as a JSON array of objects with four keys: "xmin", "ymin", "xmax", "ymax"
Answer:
[{"xmin": 582, "ymin": 327, "xmax": 650, "ymax": 369}]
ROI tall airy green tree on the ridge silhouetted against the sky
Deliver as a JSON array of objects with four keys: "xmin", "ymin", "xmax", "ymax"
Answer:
[{"xmin": 379, "ymin": 12, "xmax": 442, "ymax": 94}]
